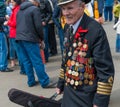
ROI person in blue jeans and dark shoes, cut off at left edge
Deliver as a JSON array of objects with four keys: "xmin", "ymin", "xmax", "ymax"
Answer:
[{"xmin": 0, "ymin": 0, "xmax": 13, "ymax": 72}]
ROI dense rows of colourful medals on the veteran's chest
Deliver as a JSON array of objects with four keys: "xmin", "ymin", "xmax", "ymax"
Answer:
[{"xmin": 65, "ymin": 38, "xmax": 95, "ymax": 89}]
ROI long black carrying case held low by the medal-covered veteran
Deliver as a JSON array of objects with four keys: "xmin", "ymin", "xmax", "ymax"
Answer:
[{"xmin": 8, "ymin": 88, "xmax": 61, "ymax": 107}]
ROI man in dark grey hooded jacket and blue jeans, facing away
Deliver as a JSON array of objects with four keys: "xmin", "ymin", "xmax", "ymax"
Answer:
[{"xmin": 16, "ymin": 0, "xmax": 56, "ymax": 88}]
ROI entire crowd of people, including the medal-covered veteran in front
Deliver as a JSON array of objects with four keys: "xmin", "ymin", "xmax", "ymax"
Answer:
[{"xmin": 0, "ymin": 0, "xmax": 120, "ymax": 107}]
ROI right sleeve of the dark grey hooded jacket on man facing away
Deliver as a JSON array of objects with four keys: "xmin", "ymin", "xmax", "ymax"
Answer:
[{"xmin": 33, "ymin": 8, "xmax": 44, "ymax": 40}]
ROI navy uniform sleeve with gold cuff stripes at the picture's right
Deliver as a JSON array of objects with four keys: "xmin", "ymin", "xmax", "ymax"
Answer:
[{"xmin": 92, "ymin": 28, "xmax": 114, "ymax": 107}]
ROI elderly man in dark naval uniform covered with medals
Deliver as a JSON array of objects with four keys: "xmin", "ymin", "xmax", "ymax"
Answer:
[{"xmin": 56, "ymin": 0, "xmax": 114, "ymax": 107}]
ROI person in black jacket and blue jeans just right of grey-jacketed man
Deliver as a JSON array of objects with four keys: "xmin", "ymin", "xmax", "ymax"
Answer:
[{"xmin": 39, "ymin": 0, "xmax": 52, "ymax": 62}]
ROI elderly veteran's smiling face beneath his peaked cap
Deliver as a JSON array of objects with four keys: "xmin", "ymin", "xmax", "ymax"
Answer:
[{"xmin": 61, "ymin": 0, "xmax": 85, "ymax": 24}]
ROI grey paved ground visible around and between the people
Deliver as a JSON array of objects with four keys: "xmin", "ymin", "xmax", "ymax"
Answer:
[{"xmin": 0, "ymin": 22, "xmax": 120, "ymax": 107}]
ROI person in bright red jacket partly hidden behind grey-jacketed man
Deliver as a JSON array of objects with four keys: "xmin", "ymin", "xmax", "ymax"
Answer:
[{"xmin": 4, "ymin": 0, "xmax": 24, "ymax": 72}]
